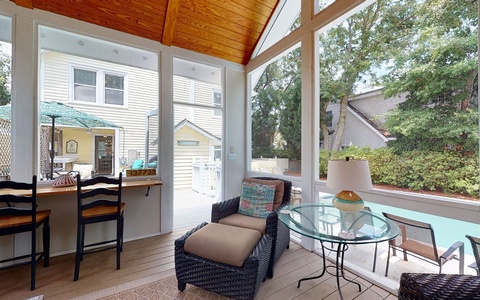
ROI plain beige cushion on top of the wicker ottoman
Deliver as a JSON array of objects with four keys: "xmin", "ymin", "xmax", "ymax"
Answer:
[{"xmin": 185, "ymin": 223, "xmax": 262, "ymax": 267}]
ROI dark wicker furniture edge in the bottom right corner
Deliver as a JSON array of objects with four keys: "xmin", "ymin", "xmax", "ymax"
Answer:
[{"xmin": 398, "ymin": 273, "xmax": 480, "ymax": 300}]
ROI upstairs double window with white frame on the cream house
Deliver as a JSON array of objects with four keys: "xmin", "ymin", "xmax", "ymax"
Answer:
[{"xmin": 72, "ymin": 67, "xmax": 126, "ymax": 106}]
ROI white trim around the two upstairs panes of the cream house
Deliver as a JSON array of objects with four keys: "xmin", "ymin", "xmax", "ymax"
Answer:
[{"xmin": 68, "ymin": 64, "xmax": 128, "ymax": 108}]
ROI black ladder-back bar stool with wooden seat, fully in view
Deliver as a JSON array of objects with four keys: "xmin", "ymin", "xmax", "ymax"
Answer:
[{"xmin": 73, "ymin": 173, "xmax": 125, "ymax": 281}]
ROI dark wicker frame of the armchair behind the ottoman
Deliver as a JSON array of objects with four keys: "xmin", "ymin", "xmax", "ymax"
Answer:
[{"xmin": 212, "ymin": 177, "xmax": 292, "ymax": 278}]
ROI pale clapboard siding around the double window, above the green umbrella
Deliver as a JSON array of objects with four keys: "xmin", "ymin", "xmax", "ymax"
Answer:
[{"xmin": 44, "ymin": 51, "xmax": 158, "ymax": 164}]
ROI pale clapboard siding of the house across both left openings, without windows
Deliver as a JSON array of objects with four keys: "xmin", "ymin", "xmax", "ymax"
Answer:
[{"xmin": 43, "ymin": 51, "xmax": 222, "ymax": 188}]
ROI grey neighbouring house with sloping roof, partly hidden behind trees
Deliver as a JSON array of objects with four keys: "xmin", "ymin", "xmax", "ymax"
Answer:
[{"xmin": 327, "ymin": 89, "xmax": 405, "ymax": 148}]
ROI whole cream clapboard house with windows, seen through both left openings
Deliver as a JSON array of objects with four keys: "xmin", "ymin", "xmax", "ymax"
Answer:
[{"xmin": 41, "ymin": 50, "xmax": 222, "ymax": 188}]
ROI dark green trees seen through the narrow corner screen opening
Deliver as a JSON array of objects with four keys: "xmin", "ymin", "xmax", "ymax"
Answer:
[{"xmin": 252, "ymin": 49, "xmax": 301, "ymax": 159}]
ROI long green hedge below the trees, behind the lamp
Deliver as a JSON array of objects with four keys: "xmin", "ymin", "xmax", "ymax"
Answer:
[{"xmin": 320, "ymin": 147, "xmax": 480, "ymax": 197}]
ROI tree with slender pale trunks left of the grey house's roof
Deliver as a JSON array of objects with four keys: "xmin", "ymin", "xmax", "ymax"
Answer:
[{"xmin": 319, "ymin": 0, "xmax": 416, "ymax": 150}]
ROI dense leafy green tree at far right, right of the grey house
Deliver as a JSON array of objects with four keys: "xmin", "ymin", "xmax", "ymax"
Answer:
[{"xmin": 381, "ymin": 0, "xmax": 478, "ymax": 154}]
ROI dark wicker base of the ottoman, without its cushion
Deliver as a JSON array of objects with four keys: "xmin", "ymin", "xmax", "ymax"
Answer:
[{"xmin": 175, "ymin": 223, "xmax": 272, "ymax": 299}]
